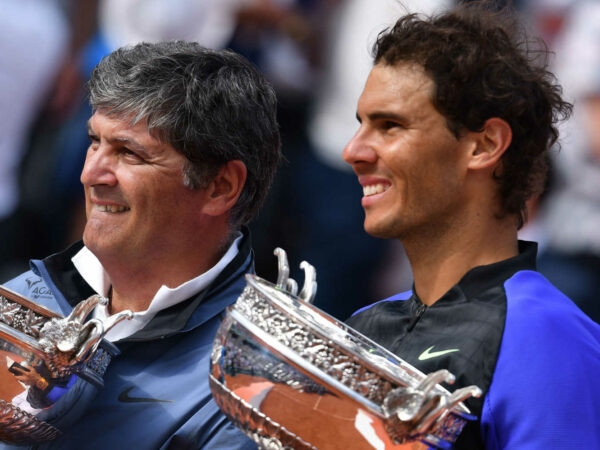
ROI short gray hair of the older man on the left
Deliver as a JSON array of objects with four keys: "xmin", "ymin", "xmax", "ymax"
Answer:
[{"xmin": 88, "ymin": 41, "xmax": 281, "ymax": 229}]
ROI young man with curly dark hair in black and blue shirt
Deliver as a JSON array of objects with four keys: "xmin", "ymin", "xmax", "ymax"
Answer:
[{"xmin": 343, "ymin": 3, "xmax": 600, "ymax": 450}]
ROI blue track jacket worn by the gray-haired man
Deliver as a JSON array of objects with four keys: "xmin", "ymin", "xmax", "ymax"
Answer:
[{"xmin": 0, "ymin": 230, "xmax": 256, "ymax": 450}]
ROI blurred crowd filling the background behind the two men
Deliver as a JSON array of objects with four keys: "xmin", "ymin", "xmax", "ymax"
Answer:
[{"xmin": 0, "ymin": 0, "xmax": 600, "ymax": 321}]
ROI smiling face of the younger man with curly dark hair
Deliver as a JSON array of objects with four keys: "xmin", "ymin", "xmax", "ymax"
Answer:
[{"xmin": 343, "ymin": 64, "xmax": 476, "ymax": 243}]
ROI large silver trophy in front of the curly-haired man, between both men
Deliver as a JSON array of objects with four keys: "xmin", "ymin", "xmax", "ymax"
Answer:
[{"xmin": 209, "ymin": 249, "xmax": 481, "ymax": 450}]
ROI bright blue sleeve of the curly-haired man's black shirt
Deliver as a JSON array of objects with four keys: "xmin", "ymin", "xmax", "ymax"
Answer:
[{"xmin": 482, "ymin": 272, "xmax": 600, "ymax": 450}]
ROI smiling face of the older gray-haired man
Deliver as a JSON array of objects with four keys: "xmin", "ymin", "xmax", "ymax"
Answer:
[{"xmin": 81, "ymin": 112, "xmax": 205, "ymax": 263}]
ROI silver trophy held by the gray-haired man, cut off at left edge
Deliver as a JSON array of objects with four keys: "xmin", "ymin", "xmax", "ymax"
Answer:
[{"xmin": 0, "ymin": 286, "xmax": 131, "ymax": 444}]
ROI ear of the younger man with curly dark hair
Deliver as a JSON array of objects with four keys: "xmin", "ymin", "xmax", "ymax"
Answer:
[{"xmin": 469, "ymin": 117, "xmax": 512, "ymax": 169}]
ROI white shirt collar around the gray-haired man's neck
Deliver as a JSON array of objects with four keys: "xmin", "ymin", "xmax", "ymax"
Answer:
[{"xmin": 71, "ymin": 233, "xmax": 242, "ymax": 341}]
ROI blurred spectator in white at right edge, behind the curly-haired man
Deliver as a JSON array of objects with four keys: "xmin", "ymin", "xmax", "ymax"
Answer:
[{"xmin": 538, "ymin": 1, "xmax": 600, "ymax": 322}]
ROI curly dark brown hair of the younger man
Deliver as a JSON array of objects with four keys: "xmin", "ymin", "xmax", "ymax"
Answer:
[{"xmin": 373, "ymin": 1, "xmax": 572, "ymax": 228}]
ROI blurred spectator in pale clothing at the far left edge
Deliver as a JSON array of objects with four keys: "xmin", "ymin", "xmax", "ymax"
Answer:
[{"xmin": 0, "ymin": 0, "xmax": 69, "ymax": 280}]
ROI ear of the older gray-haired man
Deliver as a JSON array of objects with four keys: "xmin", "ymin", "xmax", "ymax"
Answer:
[{"xmin": 202, "ymin": 159, "xmax": 248, "ymax": 216}]
